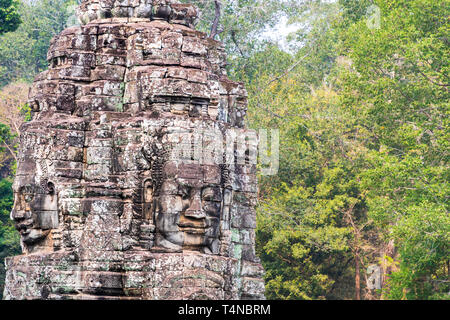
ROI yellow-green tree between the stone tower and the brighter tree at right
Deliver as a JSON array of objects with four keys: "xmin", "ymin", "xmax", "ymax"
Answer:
[{"xmin": 250, "ymin": 66, "xmax": 374, "ymax": 299}]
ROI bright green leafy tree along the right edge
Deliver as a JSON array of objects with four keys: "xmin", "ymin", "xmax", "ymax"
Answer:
[{"xmin": 342, "ymin": 0, "xmax": 450, "ymax": 299}]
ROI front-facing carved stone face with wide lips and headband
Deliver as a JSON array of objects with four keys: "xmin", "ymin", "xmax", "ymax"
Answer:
[{"xmin": 155, "ymin": 162, "xmax": 223, "ymax": 254}]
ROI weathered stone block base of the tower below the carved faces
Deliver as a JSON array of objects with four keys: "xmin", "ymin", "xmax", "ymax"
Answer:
[{"xmin": 4, "ymin": 252, "xmax": 264, "ymax": 300}]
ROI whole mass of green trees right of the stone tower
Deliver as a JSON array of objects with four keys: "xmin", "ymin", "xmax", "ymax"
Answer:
[{"xmin": 247, "ymin": 0, "xmax": 450, "ymax": 299}]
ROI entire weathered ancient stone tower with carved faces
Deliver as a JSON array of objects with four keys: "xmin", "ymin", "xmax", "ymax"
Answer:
[{"xmin": 4, "ymin": 0, "xmax": 264, "ymax": 299}]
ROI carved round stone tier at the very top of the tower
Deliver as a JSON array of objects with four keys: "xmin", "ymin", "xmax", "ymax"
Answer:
[{"xmin": 77, "ymin": 0, "xmax": 198, "ymax": 27}]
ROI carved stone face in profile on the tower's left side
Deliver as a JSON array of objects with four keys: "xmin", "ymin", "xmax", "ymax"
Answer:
[{"xmin": 11, "ymin": 164, "xmax": 58, "ymax": 249}]
